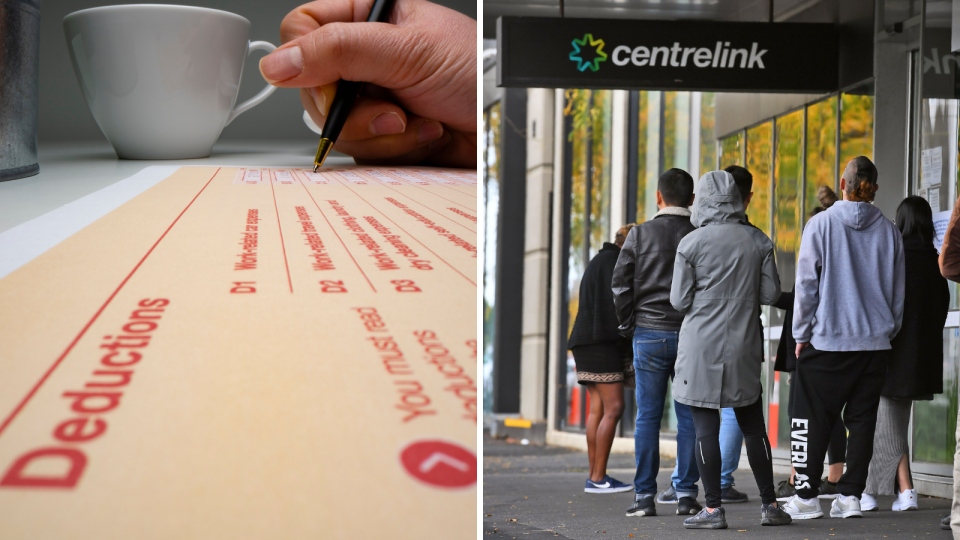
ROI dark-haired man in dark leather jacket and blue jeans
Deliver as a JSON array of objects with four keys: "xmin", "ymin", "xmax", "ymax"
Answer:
[{"xmin": 612, "ymin": 169, "xmax": 701, "ymax": 517}]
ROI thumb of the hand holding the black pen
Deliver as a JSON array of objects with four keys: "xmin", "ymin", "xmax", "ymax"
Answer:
[{"xmin": 260, "ymin": 23, "xmax": 424, "ymax": 89}]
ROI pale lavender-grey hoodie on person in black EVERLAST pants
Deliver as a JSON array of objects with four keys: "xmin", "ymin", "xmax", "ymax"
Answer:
[{"xmin": 793, "ymin": 201, "xmax": 904, "ymax": 351}]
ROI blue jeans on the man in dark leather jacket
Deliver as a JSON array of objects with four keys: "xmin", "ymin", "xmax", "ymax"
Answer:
[{"xmin": 633, "ymin": 328, "xmax": 700, "ymax": 498}]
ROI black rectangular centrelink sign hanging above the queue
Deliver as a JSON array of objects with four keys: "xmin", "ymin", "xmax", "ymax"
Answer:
[{"xmin": 497, "ymin": 17, "xmax": 839, "ymax": 93}]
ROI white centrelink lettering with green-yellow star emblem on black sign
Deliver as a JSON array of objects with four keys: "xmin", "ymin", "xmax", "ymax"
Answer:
[{"xmin": 570, "ymin": 34, "xmax": 767, "ymax": 72}]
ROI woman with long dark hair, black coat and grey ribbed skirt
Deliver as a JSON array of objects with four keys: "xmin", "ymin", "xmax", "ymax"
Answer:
[{"xmin": 860, "ymin": 196, "xmax": 950, "ymax": 511}]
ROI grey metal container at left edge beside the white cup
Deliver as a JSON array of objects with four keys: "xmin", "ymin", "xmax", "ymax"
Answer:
[{"xmin": 0, "ymin": 0, "xmax": 40, "ymax": 182}]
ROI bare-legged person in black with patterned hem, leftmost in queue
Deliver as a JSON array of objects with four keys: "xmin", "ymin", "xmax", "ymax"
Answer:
[{"xmin": 567, "ymin": 223, "xmax": 633, "ymax": 493}]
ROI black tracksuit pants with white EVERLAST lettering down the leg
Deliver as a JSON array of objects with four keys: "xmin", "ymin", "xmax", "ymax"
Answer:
[{"xmin": 790, "ymin": 345, "xmax": 890, "ymax": 499}]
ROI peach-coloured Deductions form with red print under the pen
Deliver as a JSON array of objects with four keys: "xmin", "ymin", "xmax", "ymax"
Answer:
[{"xmin": 0, "ymin": 166, "xmax": 478, "ymax": 539}]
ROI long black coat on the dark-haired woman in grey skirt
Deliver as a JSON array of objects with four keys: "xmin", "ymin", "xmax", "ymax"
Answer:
[{"xmin": 881, "ymin": 238, "xmax": 950, "ymax": 399}]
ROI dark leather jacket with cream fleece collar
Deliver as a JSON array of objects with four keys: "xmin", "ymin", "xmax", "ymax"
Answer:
[{"xmin": 613, "ymin": 208, "xmax": 695, "ymax": 336}]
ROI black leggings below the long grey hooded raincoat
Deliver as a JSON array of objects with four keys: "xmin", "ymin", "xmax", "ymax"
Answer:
[{"xmin": 690, "ymin": 397, "xmax": 777, "ymax": 508}]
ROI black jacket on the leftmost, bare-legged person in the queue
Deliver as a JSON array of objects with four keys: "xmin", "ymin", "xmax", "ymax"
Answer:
[{"xmin": 567, "ymin": 242, "xmax": 624, "ymax": 349}]
